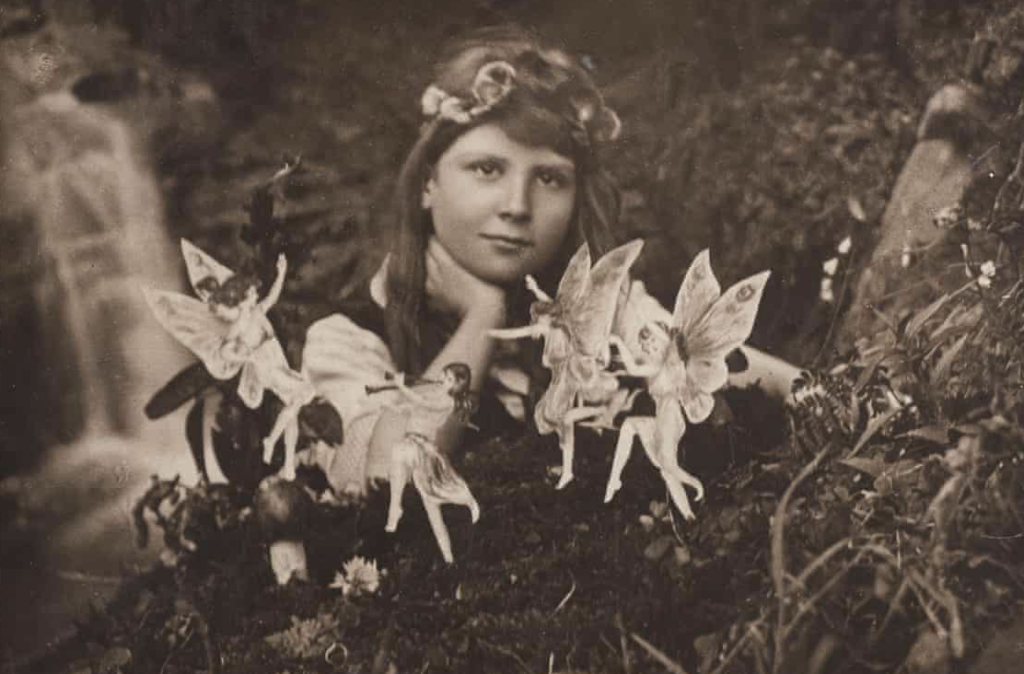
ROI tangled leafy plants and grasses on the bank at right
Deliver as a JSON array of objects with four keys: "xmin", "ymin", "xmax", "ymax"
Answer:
[{"xmin": 703, "ymin": 146, "xmax": 1024, "ymax": 673}]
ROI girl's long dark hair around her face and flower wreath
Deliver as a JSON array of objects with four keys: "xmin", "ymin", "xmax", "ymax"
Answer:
[{"xmin": 386, "ymin": 26, "xmax": 620, "ymax": 374}]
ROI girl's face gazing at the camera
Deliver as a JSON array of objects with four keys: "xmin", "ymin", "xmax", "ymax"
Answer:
[{"xmin": 423, "ymin": 124, "xmax": 577, "ymax": 285}]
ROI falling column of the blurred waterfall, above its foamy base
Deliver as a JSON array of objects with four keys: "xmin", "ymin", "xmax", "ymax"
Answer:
[{"xmin": 13, "ymin": 91, "xmax": 190, "ymax": 438}]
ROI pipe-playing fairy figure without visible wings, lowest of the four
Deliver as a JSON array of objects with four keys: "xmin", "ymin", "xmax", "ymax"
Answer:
[{"xmin": 374, "ymin": 363, "xmax": 480, "ymax": 563}]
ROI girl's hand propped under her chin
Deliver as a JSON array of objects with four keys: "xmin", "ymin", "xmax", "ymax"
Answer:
[{"xmin": 426, "ymin": 237, "xmax": 505, "ymax": 327}]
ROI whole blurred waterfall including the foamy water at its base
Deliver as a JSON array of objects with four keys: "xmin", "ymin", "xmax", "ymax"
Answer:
[{"xmin": 0, "ymin": 40, "xmax": 211, "ymax": 661}]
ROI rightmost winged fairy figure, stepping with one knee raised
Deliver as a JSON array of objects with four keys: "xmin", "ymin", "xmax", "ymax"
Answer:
[{"xmin": 605, "ymin": 250, "xmax": 769, "ymax": 519}]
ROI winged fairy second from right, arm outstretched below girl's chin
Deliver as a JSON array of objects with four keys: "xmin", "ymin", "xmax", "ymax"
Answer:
[{"xmin": 489, "ymin": 240, "xmax": 643, "ymax": 489}]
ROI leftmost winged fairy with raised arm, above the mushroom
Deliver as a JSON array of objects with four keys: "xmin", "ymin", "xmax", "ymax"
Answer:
[{"xmin": 143, "ymin": 239, "xmax": 315, "ymax": 479}]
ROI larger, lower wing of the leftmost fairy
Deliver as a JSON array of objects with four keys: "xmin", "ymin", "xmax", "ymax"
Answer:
[{"xmin": 142, "ymin": 288, "xmax": 242, "ymax": 379}]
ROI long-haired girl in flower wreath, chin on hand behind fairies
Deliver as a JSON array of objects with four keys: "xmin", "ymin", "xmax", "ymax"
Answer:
[{"xmin": 303, "ymin": 28, "xmax": 799, "ymax": 520}]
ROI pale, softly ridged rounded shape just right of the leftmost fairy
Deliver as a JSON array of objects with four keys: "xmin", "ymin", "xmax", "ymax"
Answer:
[{"xmin": 302, "ymin": 313, "xmax": 396, "ymax": 425}]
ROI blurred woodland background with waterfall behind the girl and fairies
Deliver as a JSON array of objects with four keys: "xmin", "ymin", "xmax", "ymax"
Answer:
[{"xmin": 0, "ymin": 0, "xmax": 1024, "ymax": 663}]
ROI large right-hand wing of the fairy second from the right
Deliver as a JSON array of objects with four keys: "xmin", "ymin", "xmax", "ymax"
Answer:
[{"xmin": 559, "ymin": 239, "xmax": 643, "ymax": 355}]
